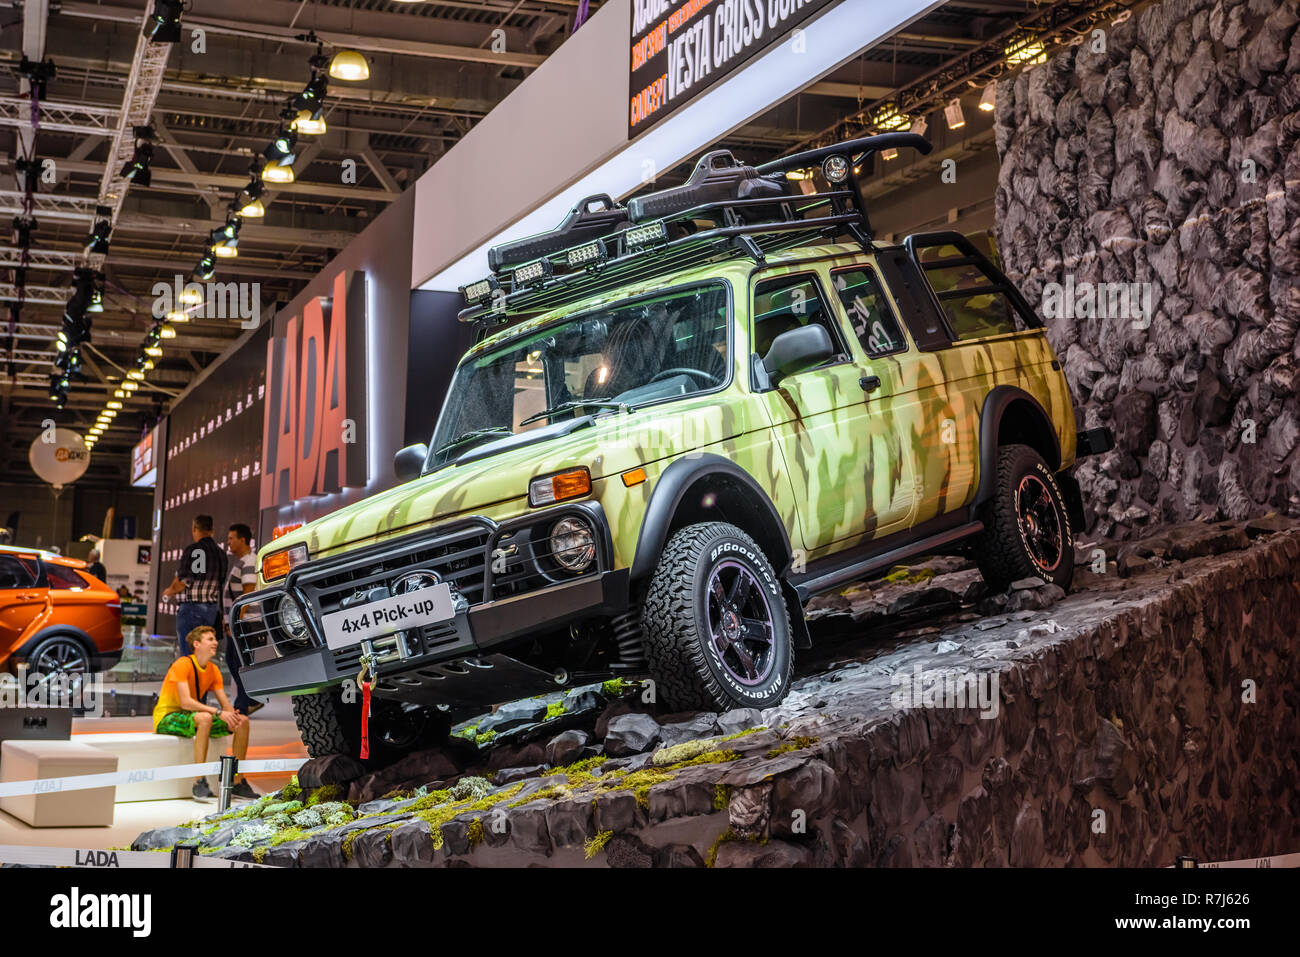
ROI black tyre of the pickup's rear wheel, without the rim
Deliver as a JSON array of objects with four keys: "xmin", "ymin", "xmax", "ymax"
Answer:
[{"xmin": 972, "ymin": 445, "xmax": 1074, "ymax": 592}]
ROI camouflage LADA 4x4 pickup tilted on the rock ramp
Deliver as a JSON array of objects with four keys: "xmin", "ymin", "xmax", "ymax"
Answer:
[{"xmin": 231, "ymin": 134, "xmax": 1110, "ymax": 754}]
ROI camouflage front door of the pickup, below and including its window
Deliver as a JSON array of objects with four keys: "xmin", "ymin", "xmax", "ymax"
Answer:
[{"xmin": 750, "ymin": 269, "xmax": 913, "ymax": 559}]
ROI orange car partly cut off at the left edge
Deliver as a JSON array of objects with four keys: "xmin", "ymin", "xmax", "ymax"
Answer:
[{"xmin": 0, "ymin": 546, "xmax": 122, "ymax": 675}]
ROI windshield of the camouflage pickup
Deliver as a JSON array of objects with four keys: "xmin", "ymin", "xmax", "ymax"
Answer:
[{"xmin": 428, "ymin": 282, "xmax": 728, "ymax": 468}]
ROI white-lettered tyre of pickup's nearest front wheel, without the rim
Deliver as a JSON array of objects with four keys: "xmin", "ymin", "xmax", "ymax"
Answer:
[{"xmin": 642, "ymin": 521, "xmax": 794, "ymax": 711}]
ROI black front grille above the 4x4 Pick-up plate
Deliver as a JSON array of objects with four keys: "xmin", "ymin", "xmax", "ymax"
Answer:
[{"xmin": 294, "ymin": 523, "xmax": 491, "ymax": 615}]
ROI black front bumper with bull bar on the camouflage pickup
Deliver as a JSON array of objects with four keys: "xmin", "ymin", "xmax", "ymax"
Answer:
[{"xmin": 230, "ymin": 502, "xmax": 628, "ymax": 705}]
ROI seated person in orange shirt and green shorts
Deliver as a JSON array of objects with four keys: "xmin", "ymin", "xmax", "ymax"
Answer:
[{"xmin": 153, "ymin": 624, "xmax": 260, "ymax": 801}]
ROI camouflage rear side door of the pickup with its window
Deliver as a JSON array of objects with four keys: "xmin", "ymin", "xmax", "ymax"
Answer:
[{"xmin": 831, "ymin": 261, "xmax": 978, "ymax": 524}]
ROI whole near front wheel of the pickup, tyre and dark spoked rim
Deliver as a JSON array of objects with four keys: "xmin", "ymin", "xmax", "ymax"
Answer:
[{"xmin": 642, "ymin": 521, "xmax": 794, "ymax": 711}]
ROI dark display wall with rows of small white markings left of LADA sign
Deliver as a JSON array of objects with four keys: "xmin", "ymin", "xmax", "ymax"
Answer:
[{"xmin": 151, "ymin": 326, "xmax": 269, "ymax": 635}]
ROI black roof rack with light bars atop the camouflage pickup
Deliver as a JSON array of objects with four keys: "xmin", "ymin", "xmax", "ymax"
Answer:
[{"xmin": 459, "ymin": 133, "xmax": 931, "ymax": 324}]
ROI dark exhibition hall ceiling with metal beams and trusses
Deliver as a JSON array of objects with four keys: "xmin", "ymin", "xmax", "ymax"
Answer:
[{"xmin": 0, "ymin": 0, "xmax": 1114, "ymax": 486}]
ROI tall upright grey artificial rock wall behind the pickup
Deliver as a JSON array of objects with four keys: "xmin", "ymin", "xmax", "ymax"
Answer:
[{"xmin": 996, "ymin": 0, "xmax": 1300, "ymax": 536}]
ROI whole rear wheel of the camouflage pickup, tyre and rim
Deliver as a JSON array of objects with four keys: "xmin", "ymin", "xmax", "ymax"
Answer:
[{"xmin": 975, "ymin": 445, "xmax": 1074, "ymax": 592}]
